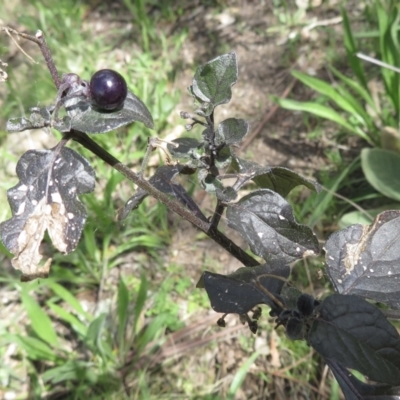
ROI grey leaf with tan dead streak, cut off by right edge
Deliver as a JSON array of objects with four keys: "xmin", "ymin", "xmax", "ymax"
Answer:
[{"xmin": 325, "ymin": 210, "xmax": 400, "ymax": 309}]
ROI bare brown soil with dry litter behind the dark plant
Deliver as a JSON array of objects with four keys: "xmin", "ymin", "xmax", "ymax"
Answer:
[{"xmin": 3, "ymin": 1, "xmax": 358, "ymax": 400}]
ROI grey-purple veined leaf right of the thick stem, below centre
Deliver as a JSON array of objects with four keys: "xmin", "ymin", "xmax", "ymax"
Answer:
[{"xmin": 226, "ymin": 189, "xmax": 319, "ymax": 263}]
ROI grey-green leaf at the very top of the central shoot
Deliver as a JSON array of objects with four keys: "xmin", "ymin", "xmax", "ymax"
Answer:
[{"xmin": 190, "ymin": 52, "xmax": 238, "ymax": 115}]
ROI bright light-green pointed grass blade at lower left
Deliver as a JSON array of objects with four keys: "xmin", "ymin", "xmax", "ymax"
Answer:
[{"xmin": 21, "ymin": 290, "xmax": 58, "ymax": 347}]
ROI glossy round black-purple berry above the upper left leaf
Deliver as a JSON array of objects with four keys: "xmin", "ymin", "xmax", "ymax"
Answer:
[{"xmin": 90, "ymin": 69, "xmax": 128, "ymax": 111}]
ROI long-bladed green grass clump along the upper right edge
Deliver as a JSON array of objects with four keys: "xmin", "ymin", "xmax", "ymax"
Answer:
[{"xmin": 276, "ymin": 0, "xmax": 400, "ymax": 233}]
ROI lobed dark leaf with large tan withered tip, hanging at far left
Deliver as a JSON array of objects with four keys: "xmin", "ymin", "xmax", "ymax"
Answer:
[{"xmin": 0, "ymin": 147, "xmax": 95, "ymax": 281}]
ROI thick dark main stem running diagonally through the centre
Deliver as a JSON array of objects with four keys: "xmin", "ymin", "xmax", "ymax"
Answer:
[{"xmin": 70, "ymin": 130, "xmax": 259, "ymax": 267}]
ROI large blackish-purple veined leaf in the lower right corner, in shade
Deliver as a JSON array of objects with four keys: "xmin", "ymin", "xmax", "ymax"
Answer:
[{"xmin": 308, "ymin": 294, "xmax": 400, "ymax": 385}]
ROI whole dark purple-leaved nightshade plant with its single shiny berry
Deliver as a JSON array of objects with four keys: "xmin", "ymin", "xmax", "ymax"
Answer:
[{"xmin": 0, "ymin": 28, "xmax": 400, "ymax": 400}]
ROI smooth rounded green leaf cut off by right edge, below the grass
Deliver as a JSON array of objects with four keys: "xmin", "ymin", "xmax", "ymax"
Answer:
[{"xmin": 361, "ymin": 148, "xmax": 400, "ymax": 201}]
